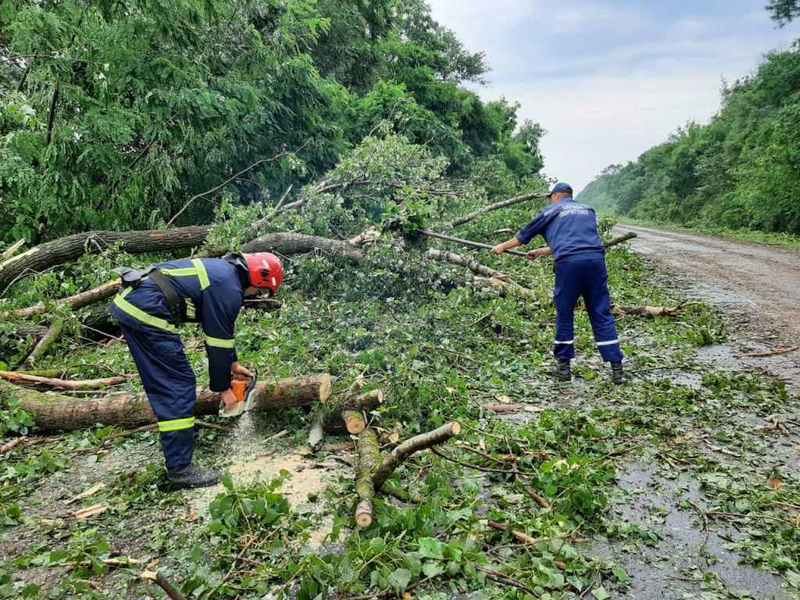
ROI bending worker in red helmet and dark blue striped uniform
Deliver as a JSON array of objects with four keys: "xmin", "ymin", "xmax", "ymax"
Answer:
[{"xmin": 111, "ymin": 252, "xmax": 284, "ymax": 489}]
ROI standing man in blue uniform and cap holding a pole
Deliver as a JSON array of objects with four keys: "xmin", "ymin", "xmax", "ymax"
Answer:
[{"xmin": 494, "ymin": 183, "xmax": 624, "ymax": 384}]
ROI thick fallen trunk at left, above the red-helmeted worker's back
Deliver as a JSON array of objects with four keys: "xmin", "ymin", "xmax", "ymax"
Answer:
[{"xmin": 0, "ymin": 226, "xmax": 211, "ymax": 290}]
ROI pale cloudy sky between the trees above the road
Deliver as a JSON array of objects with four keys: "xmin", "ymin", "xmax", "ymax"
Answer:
[{"xmin": 429, "ymin": 0, "xmax": 800, "ymax": 191}]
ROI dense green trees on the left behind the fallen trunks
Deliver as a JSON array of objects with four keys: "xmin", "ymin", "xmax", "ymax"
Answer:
[{"xmin": 0, "ymin": 0, "xmax": 542, "ymax": 242}]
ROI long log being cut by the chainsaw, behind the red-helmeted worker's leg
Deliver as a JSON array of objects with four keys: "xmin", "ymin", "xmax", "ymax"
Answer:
[{"xmin": 0, "ymin": 374, "xmax": 331, "ymax": 431}]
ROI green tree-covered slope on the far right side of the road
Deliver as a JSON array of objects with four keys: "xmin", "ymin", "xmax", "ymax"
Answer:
[{"xmin": 580, "ymin": 44, "xmax": 800, "ymax": 234}]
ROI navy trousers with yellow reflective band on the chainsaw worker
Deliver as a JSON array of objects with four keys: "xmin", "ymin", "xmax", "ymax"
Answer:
[{"xmin": 112, "ymin": 307, "xmax": 197, "ymax": 470}]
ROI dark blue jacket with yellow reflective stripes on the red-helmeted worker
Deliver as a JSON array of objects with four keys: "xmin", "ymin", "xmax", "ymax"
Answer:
[{"xmin": 114, "ymin": 258, "xmax": 244, "ymax": 392}]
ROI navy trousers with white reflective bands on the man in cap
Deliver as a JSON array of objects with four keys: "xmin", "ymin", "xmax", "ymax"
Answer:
[{"xmin": 553, "ymin": 254, "xmax": 622, "ymax": 362}]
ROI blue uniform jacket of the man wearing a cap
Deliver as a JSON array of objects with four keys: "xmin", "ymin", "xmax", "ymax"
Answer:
[{"xmin": 517, "ymin": 198, "xmax": 605, "ymax": 263}]
